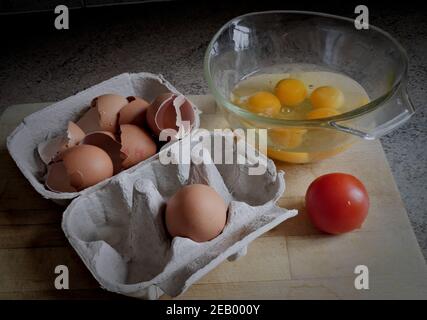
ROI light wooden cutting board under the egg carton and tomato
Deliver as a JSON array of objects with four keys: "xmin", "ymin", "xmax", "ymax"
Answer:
[{"xmin": 0, "ymin": 96, "xmax": 427, "ymax": 299}]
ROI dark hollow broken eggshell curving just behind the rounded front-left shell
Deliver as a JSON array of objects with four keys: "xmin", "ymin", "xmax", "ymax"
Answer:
[{"xmin": 82, "ymin": 131, "xmax": 126, "ymax": 174}]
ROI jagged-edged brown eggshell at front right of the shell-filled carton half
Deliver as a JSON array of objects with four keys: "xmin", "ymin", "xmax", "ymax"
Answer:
[{"xmin": 120, "ymin": 124, "xmax": 157, "ymax": 169}]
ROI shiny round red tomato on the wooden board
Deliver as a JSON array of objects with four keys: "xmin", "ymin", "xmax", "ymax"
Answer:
[{"xmin": 305, "ymin": 173, "xmax": 369, "ymax": 234}]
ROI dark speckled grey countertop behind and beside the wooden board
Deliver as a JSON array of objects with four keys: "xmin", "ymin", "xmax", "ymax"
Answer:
[{"xmin": 0, "ymin": 1, "xmax": 427, "ymax": 257}]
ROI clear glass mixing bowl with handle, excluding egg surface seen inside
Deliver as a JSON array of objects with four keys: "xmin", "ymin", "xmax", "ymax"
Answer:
[{"xmin": 204, "ymin": 11, "xmax": 414, "ymax": 163}]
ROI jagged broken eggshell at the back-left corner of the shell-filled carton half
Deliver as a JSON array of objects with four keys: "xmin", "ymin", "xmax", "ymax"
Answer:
[{"xmin": 37, "ymin": 121, "xmax": 85, "ymax": 164}]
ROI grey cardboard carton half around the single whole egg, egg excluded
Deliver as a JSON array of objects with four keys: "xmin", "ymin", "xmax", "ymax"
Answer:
[{"xmin": 62, "ymin": 133, "xmax": 297, "ymax": 299}]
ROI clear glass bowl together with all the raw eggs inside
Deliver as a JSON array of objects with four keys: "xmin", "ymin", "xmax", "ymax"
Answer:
[{"xmin": 204, "ymin": 11, "xmax": 414, "ymax": 163}]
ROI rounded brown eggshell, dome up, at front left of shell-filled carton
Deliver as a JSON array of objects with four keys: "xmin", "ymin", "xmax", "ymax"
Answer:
[{"xmin": 62, "ymin": 144, "xmax": 113, "ymax": 191}]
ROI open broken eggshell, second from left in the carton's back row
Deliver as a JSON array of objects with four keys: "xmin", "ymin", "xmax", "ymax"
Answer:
[{"xmin": 77, "ymin": 94, "xmax": 128, "ymax": 133}]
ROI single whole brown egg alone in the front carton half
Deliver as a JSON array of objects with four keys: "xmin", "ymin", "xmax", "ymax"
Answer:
[{"xmin": 165, "ymin": 184, "xmax": 227, "ymax": 242}]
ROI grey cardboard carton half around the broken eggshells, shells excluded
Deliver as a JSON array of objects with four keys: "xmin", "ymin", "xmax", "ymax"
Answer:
[{"xmin": 7, "ymin": 72, "xmax": 200, "ymax": 205}]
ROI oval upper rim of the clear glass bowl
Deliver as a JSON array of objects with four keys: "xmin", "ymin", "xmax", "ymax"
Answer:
[{"xmin": 203, "ymin": 10, "xmax": 408, "ymax": 128}]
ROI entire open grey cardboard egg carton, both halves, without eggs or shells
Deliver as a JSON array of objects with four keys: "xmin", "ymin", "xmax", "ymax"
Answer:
[{"xmin": 7, "ymin": 73, "xmax": 297, "ymax": 299}]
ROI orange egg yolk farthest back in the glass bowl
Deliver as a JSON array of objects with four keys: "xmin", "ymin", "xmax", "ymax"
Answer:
[{"xmin": 274, "ymin": 79, "xmax": 307, "ymax": 107}]
